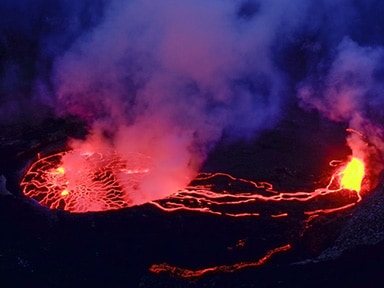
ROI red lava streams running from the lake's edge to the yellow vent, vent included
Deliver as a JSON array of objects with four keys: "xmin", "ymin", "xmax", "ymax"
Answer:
[{"xmin": 151, "ymin": 158, "xmax": 364, "ymax": 218}]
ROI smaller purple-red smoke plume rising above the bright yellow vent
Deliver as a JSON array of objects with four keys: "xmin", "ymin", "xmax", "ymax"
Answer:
[{"xmin": 298, "ymin": 37, "xmax": 384, "ymax": 185}]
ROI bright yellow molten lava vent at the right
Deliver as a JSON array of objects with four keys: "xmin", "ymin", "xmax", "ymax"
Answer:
[{"xmin": 340, "ymin": 157, "xmax": 365, "ymax": 192}]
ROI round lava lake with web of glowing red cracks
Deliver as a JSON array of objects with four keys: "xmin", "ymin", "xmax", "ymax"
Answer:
[{"xmin": 20, "ymin": 151, "xmax": 150, "ymax": 213}]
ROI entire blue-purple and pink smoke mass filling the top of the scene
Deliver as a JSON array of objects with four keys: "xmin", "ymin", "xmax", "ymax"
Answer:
[{"xmin": 0, "ymin": 0, "xmax": 384, "ymax": 203}]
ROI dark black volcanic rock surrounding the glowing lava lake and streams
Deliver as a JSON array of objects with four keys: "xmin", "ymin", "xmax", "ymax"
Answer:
[{"xmin": 0, "ymin": 112, "xmax": 384, "ymax": 287}]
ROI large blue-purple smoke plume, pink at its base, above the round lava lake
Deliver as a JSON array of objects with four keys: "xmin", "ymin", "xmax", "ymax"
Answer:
[{"xmin": 55, "ymin": 1, "xmax": 292, "ymax": 204}]
